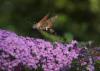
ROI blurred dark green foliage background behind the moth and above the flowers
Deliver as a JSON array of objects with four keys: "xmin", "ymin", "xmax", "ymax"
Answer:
[{"xmin": 0, "ymin": 0, "xmax": 100, "ymax": 42}]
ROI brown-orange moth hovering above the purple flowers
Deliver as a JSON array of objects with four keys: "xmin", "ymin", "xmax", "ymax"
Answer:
[{"xmin": 33, "ymin": 14, "xmax": 58, "ymax": 33}]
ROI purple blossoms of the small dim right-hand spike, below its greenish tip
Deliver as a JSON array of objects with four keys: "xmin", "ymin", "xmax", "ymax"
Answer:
[{"xmin": 78, "ymin": 48, "xmax": 95, "ymax": 71}]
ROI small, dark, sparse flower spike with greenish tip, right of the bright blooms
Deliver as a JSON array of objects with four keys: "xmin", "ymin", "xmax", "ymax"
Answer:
[{"xmin": 78, "ymin": 42, "xmax": 95, "ymax": 71}]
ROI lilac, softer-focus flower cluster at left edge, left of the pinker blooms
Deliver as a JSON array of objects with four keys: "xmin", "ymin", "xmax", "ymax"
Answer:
[{"xmin": 0, "ymin": 30, "xmax": 37, "ymax": 71}]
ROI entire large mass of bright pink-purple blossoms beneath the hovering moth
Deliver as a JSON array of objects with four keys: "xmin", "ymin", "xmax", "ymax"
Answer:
[{"xmin": 0, "ymin": 30, "xmax": 80, "ymax": 71}]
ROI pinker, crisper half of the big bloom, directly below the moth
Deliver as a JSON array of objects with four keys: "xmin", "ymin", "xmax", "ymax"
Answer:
[{"xmin": 23, "ymin": 37, "xmax": 79, "ymax": 71}]
